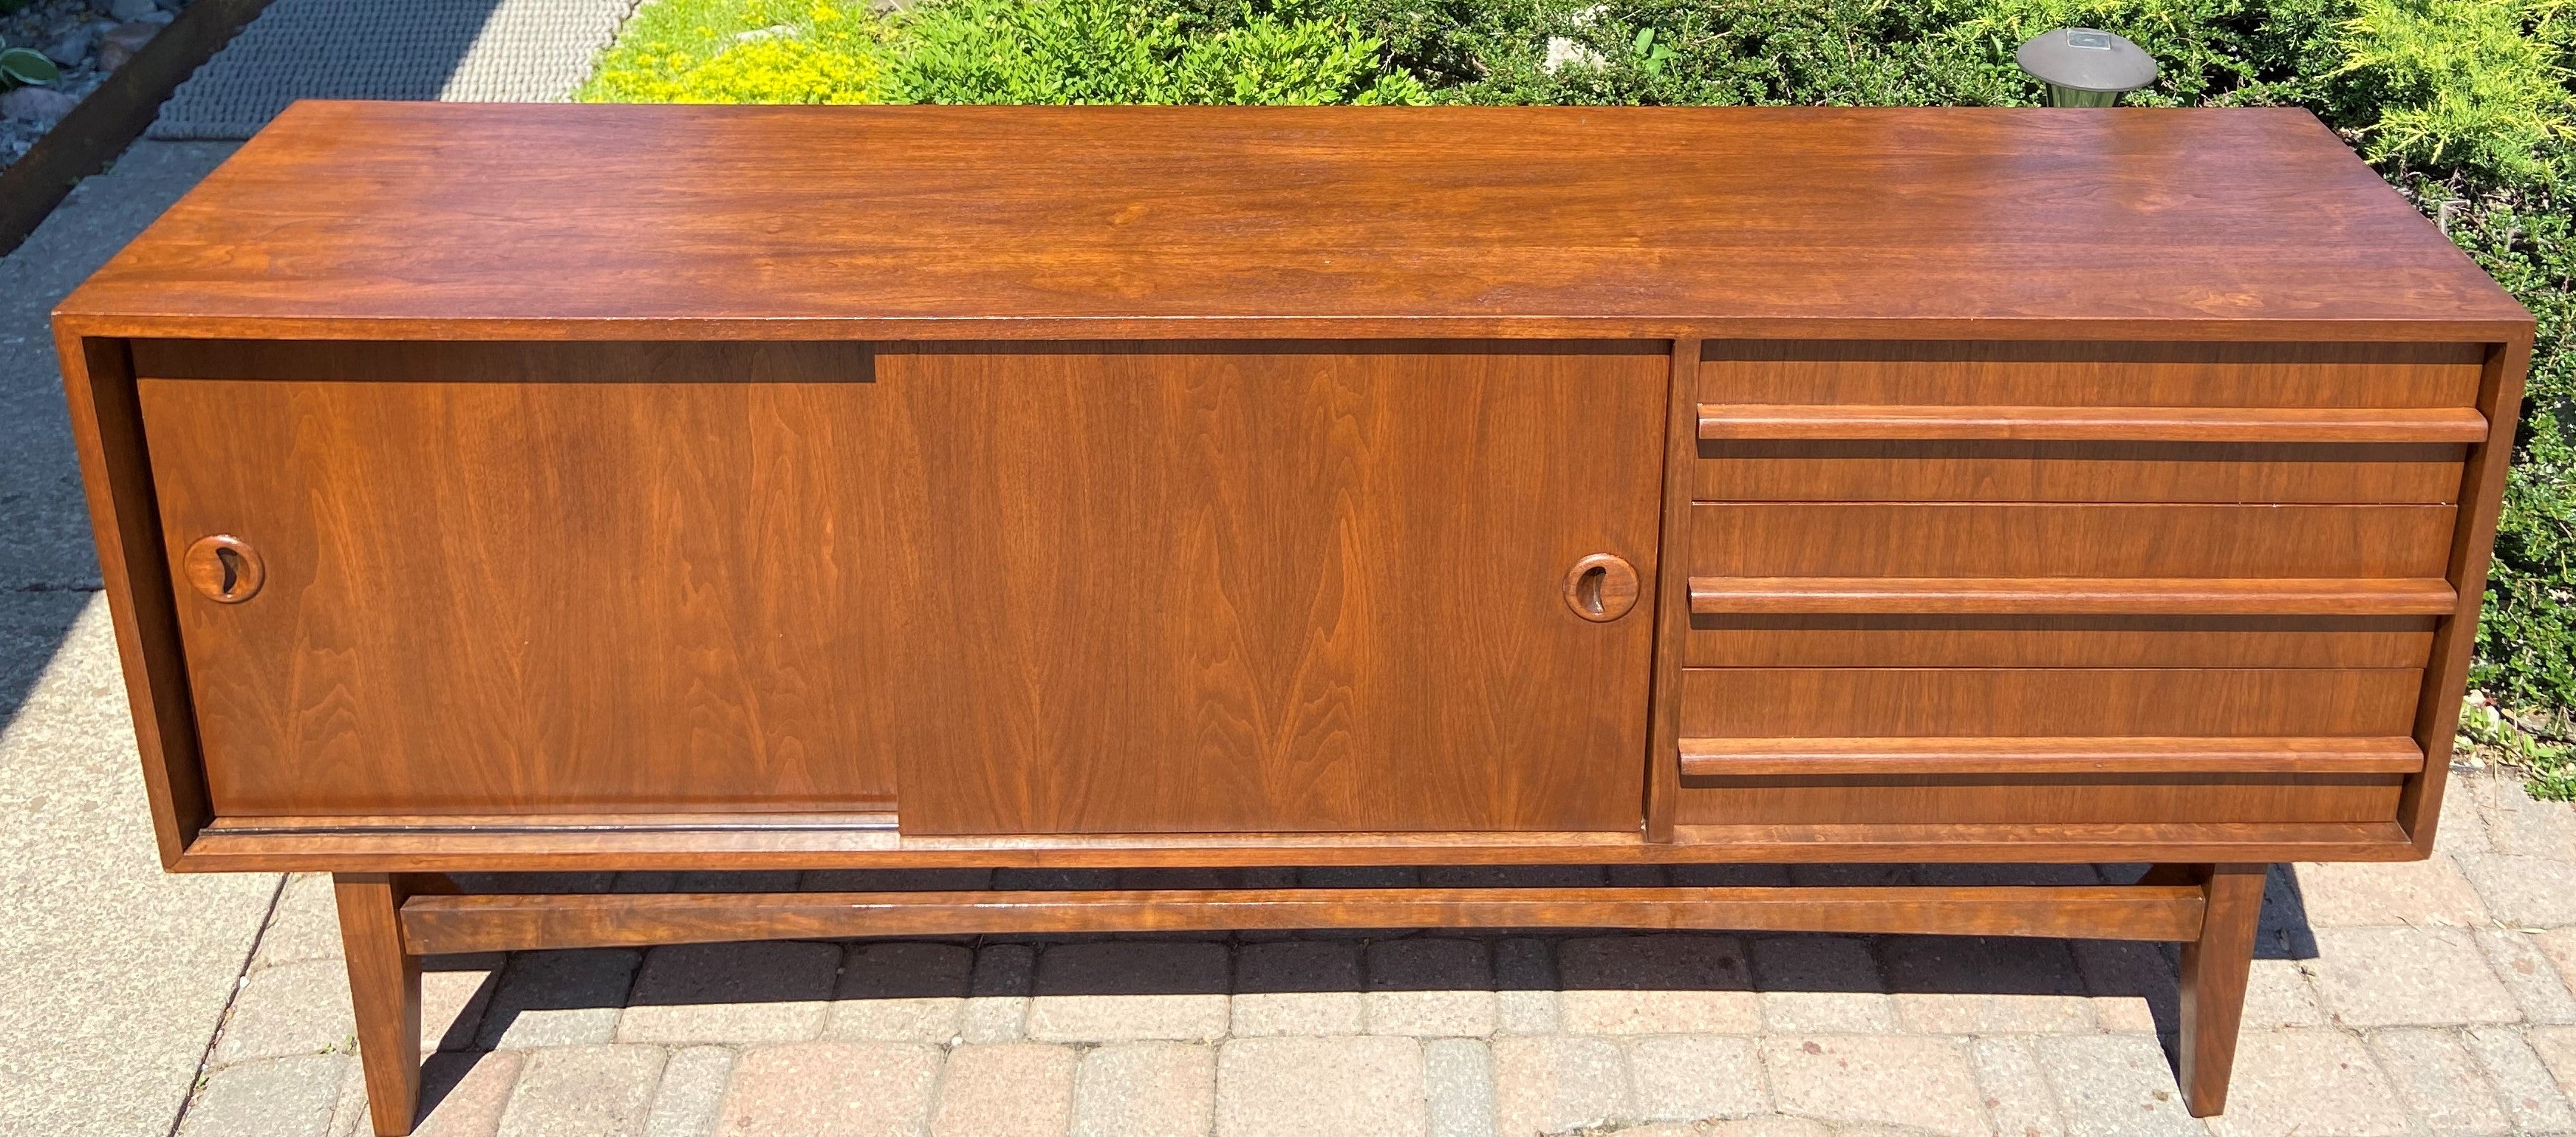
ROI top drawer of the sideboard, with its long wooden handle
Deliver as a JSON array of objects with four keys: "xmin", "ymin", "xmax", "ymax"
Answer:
[{"xmin": 1692, "ymin": 343, "xmax": 2486, "ymax": 503}]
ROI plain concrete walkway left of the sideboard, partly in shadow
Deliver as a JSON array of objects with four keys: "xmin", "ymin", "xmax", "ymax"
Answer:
[{"xmin": 0, "ymin": 142, "xmax": 279, "ymax": 1137}]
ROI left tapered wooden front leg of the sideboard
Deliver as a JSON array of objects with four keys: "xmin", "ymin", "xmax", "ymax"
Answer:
[{"xmin": 332, "ymin": 874, "xmax": 420, "ymax": 1137}]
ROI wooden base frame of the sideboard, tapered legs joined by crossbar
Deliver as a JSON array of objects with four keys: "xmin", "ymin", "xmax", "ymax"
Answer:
[{"xmin": 335, "ymin": 864, "xmax": 2267, "ymax": 1137}]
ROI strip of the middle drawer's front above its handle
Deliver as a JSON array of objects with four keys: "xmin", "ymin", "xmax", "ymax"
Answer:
[{"xmin": 1690, "ymin": 503, "xmax": 2458, "ymax": 580}]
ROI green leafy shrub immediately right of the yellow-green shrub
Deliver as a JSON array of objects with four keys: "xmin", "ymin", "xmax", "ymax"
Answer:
[{"xmin": 894, "ymin": 0, "xmax": 1424, "ymax": 106}]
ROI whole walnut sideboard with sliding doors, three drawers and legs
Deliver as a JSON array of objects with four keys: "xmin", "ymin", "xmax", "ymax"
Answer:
[{"xmin": 54, "ymin": 103, "xmax": 2532, "ymax": 1135}]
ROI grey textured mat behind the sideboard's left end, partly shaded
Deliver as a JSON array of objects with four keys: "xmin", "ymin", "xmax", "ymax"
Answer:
[{"xmin": 152, "ymin": 0, "xmax": 636, "ymax": 139}]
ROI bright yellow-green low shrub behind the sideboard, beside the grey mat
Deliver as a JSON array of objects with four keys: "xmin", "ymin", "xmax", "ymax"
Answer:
[{"xmin": 575, "ymin": 0, "xmax": 889, "ymax": 103}]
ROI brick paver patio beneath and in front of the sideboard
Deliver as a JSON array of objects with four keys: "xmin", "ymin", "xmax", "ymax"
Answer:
[{"xmin": 155, "ymin": 771, "xmax": 2576, "ymax": 1137}]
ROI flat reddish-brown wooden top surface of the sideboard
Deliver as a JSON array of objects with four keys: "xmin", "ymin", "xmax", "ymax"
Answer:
[{"xmin": 59, "ymin": 103, "xmax": 2529, "ymax": 341}]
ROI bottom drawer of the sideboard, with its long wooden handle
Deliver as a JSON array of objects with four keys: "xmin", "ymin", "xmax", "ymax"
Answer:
[{"xmin": 1675, "ymin": 668, "xmax": 2424, "ymax": 825}]
